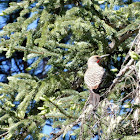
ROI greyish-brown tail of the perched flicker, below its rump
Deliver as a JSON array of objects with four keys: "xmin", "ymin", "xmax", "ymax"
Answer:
[{"xmin": 89, "ymin": 91, "xmax": 100, "ymax": 107}]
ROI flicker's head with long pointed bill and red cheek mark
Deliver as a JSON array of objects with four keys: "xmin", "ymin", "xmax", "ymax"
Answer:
[{"xmin": 88, "ymin": 54, "xmax": 109, "ymax": 67}]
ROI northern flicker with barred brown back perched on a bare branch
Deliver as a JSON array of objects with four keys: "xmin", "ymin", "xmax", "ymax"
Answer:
[{"xmin": 84, "ymin": 54, "xmax": 109, "ymax": 106}]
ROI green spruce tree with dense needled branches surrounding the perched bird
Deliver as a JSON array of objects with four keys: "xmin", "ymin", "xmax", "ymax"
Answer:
[{"xmin": 0, "ymin": 0, "xmax": 140, "ymax": 140}]
